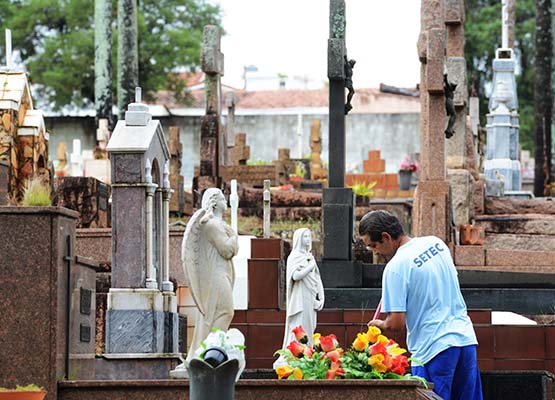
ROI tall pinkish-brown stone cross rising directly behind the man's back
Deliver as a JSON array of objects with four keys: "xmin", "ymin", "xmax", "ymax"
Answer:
[{"xmin": 413, "ymin": 0, "xmax": 450, "ymax": 241}]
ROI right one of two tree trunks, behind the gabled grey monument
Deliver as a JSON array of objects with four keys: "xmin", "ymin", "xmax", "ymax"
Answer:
[{"xmin": 117, "ymin": 0, "xmax": 139, "ymax": 119}]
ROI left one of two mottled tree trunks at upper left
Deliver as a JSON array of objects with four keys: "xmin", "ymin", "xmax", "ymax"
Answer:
[{"xmin": 94, "ymin": 0, "xmax": 113, "ymax": 125}]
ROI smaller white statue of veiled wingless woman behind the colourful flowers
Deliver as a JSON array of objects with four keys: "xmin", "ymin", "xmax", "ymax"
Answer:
[{"xmin": 274, "ymin": 228, "xmax": 324, "ymax": 368}]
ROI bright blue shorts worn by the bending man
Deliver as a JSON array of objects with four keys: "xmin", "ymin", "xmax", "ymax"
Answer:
[{"xmin": 412, "ymin": 345, "xmax": 482, "ymax": 400}]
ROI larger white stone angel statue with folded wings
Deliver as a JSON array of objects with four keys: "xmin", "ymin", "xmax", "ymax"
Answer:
[{"xmin": 181, "ymin": 188, "xmax": 239, "ymax": 364}]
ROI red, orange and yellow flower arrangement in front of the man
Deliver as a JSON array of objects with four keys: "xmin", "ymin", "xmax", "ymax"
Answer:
[{"xmin": 275, "ymin": 326, "xmax": 426, "ymax": 385}]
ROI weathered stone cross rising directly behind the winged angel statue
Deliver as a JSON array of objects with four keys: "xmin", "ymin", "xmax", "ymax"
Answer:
[{"xmin": 193, "ymin": 25, "xmax": 224, "ymax": 206}]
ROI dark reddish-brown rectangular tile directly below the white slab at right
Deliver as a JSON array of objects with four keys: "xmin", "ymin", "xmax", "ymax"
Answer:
[{"xmin": 494, "ymin": 325, "xmax": 545, "ymax": 360}]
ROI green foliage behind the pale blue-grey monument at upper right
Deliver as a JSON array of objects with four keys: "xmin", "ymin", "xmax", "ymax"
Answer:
[{"xmin": 464, "ymin": 0, "xmax": 536, "ymax": 151}]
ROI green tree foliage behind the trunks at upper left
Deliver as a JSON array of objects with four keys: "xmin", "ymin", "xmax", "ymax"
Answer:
[{"xmin": 0, "ymin": 0, "xmax": 221, "ymax": 109}]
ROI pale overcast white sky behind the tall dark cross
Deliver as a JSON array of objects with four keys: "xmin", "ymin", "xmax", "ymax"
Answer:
[{"xmin": 212, "ymin": 0, "xmax": 420, "ymax": 88}]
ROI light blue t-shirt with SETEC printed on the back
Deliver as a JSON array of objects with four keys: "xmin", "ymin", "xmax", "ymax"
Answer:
[{"xmin": 382, "ymin": 236, "xmax": 478, "ymax": 364}]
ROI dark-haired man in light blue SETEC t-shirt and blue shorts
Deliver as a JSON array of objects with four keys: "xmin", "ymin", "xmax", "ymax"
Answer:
[{"xmin": 359, "ymin": 210, "xmax": 482, "ymax": 400}]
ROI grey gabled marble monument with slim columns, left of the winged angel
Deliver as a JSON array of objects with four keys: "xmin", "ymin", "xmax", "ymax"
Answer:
[{"xmin": 106, "ymin": 88, "xmax": 178, "ymax": 354}]
